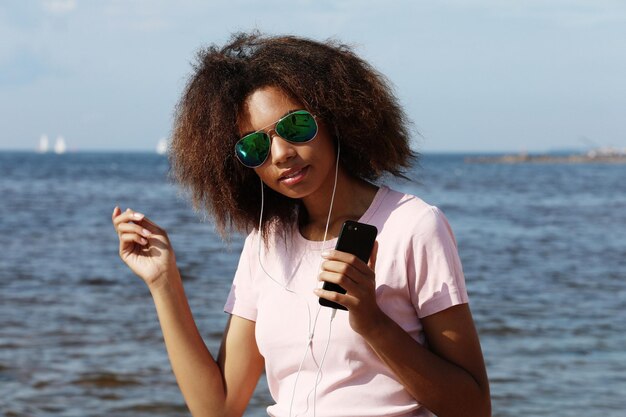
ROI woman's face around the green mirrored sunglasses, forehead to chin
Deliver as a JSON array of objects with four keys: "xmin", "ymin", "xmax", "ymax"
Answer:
[{"xmin": 239, "ymin": 86, "xmax": 336, "ymax": 203}]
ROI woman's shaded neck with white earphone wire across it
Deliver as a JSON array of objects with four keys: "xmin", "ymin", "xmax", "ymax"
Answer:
[{"xmin": 300, "ymin": 167, "xmax": 378, "ymax": 240}]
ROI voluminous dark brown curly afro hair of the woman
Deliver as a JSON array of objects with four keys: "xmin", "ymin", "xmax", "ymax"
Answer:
[{"xmin": 169, "ymin": 32, "xmax": 417, "ymax": 237}]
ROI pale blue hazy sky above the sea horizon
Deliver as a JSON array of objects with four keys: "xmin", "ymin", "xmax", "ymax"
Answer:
[{"xmin": 0, "ymin": 0, "xmax": 626, "ymax": 153}]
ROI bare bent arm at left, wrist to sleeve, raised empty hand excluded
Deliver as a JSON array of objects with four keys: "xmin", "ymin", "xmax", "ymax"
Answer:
[{"xmin": 151, "ymin": 277, "xmax": 264, "ymax": 417}]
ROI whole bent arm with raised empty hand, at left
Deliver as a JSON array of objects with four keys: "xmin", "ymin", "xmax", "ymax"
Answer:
[{"xmin": 112, "ymin": 207, "xmax": 263, "ymax": 417}]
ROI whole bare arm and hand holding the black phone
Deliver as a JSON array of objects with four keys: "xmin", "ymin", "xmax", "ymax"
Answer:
[{"xmin": 316, "ymin": 245, "xmax": 491, "ymax": 417}]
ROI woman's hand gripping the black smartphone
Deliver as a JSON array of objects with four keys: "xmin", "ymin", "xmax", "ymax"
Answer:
[{"xmin": 315, "ymin": 242, "xmax": 385, "ymax": 336}]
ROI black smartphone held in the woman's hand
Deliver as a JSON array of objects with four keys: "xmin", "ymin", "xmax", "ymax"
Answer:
[{"xmin": 320, "ymin": 220, "xmax": 378, "ymax": 310}]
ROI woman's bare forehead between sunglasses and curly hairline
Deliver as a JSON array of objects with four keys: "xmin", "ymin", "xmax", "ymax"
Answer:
[{"xmin": 238, "ymin": 86, "xmax": 303, "ymax": 132}]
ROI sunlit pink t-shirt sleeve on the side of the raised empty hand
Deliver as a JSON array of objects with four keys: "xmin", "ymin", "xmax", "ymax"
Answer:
[{"xmin": 224, "ymin": 233, "xmax": 258, "ymax": 321}]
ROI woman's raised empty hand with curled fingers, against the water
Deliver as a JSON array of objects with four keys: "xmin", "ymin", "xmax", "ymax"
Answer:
[{"xmin": 111, "ymin": 207, "xmax": 176, "ymax": 289}]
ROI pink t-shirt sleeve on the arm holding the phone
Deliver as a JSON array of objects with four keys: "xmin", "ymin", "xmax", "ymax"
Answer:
[{"xmin": 407, "ymin": 207, "xmax": 468, "ymax": 317}]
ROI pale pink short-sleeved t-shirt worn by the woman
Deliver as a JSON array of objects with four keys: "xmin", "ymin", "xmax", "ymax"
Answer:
[{"xmin": 224, "ymin": 187, "xmax": 468, "ymax": 417}]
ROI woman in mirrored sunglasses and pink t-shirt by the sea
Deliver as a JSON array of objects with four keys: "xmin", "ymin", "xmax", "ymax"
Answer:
[{"xmin": 113, "ymin": 34, "xmax": 490, "ymax": 416}]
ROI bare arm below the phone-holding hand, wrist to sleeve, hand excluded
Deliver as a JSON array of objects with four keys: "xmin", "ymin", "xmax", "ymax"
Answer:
[{"xmin": 363, "ymin": 304, "xmax": 491, "ymax": 417}]
